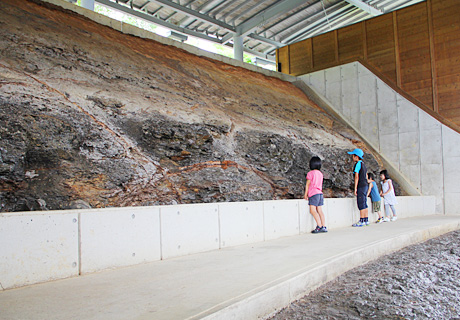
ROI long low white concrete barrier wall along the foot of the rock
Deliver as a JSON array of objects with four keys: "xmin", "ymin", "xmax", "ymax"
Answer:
[{"xmin": 0, "ymin": 196, "xmax": 436, "ymax": 290}]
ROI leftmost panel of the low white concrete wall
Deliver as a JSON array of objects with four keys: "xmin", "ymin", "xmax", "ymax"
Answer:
[{"xmin": 0, "ymin": 211, "xmax": 79, "ymax": 288}]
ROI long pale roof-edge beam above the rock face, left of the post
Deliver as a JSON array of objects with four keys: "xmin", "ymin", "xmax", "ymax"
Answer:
[{"xmin": 96, "ymin": 0, "xmax": 222, "ymax": 44}]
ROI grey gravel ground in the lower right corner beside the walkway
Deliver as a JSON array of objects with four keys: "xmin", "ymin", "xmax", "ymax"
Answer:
[{"xmin": 270, "ymin": 231, "xmax": 460, "ymax": 320}]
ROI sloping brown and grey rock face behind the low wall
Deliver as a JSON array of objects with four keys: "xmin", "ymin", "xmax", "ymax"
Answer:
[{"xmin": 0, "ymin": 0, "xmax": 398, "ymax": 211}]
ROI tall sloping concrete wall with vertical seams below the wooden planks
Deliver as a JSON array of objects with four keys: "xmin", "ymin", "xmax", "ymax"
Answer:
[{"xmin": 299, "ymin": 62, "xmax": 460, "ymax": 214}]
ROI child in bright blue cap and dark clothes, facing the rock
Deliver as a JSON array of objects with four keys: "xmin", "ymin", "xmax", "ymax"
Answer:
[{"xmin": 348, "ymin": 149, "xmax": 369, "ymax": 227}]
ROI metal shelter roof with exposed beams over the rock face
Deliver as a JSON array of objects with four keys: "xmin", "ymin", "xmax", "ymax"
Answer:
[{"xmin": 96, "ymin": 0, "xmax": 424, "ymax": 61}]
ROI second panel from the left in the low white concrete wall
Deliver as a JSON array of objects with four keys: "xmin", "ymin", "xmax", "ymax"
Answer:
[{"xmin": 80, "ymin": 207, "xmax": 161, "ymax": 273}]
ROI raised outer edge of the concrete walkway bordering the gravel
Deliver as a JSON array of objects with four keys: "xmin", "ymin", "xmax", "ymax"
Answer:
[{"xmin": 197, "ymin": 221, "xmax": 460, "ymax": 320}]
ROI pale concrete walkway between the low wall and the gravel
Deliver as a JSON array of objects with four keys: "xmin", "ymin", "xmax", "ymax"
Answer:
[{"xmin": 0, "ymin": 216, "xmax": 460, "ymax": 320}]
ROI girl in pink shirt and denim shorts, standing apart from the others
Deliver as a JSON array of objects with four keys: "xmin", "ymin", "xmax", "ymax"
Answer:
[{"xmin": 304, "ymin": 157, "xmax": 327, "ymax": 233}]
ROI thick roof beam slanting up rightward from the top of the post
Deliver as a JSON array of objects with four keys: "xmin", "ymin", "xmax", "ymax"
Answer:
[{"xmin": 236, "ymin": 0, "xmax": 305, "ymax": 36}]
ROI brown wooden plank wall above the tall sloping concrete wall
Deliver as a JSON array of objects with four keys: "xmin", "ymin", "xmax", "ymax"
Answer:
[{"xmin": 277, "ymin": 0, "xmax": 460, "ymax": 132}]
